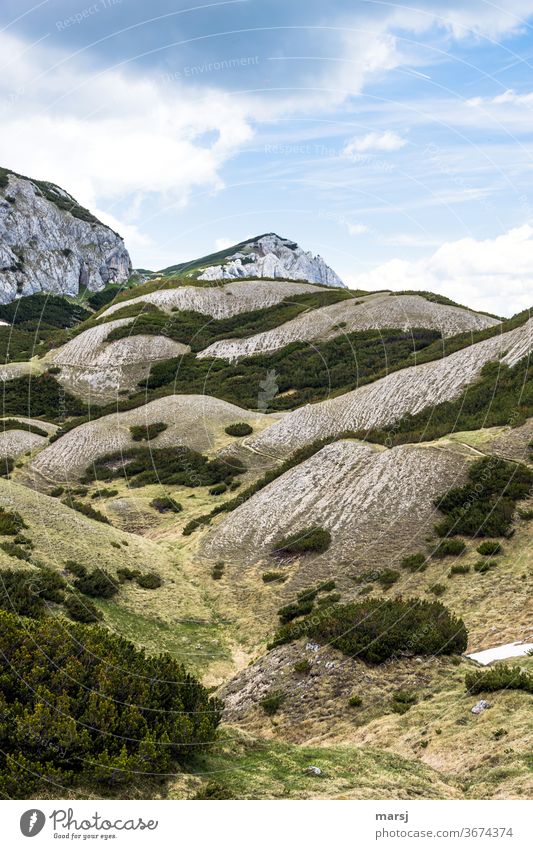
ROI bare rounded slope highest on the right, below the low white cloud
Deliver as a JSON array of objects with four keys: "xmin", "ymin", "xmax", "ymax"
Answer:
[{"xmin": 199, "ymin": 292, "xmax": 499, "ymax": 360}]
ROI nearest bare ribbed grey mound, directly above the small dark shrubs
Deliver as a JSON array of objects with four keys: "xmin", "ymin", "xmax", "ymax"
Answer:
[{"xmin": 204, "ymin": 440, "xmax": 468, "ymax": 572}]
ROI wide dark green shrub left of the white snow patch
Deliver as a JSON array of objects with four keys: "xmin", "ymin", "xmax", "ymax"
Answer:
[{"xmin": 271, "ymin": 598, "xmax": 467, "ymax": 663}]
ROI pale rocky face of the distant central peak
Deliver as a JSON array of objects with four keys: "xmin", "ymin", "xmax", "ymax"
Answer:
[{"xmin": 198, "ymin": 233, "xmax": 346, "ymax": 288}]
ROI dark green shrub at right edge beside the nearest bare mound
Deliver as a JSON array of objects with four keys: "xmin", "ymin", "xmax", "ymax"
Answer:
[{"xmin": 435, "ymin": 457, "xmax": 533, "ymax": 537}]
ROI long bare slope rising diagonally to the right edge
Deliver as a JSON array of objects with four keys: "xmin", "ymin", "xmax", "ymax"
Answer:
[{"xmin": 247, "ymin": 319, "xmax": 533, "ymax": 457}]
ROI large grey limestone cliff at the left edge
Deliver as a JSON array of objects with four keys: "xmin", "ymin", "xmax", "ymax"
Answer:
[{"xmin": 0, "ymin": 169, "xmax": 132, "ymax": 304}]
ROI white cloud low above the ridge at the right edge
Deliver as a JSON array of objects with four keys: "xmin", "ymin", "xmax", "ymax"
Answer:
[{"xmin": 350, "ymin": 224, "xmax": 533, "ymax": 316}]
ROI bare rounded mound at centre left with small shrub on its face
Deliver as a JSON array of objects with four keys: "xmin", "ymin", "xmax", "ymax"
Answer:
[{"xmin": 31, "ymin": 395, "xmax": 269, "ymax": 482}]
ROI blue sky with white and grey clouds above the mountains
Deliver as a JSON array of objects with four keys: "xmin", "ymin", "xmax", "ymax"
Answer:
[{"xmin": 0, "ymin": 0, "xmax": 533, "ymax": 316}]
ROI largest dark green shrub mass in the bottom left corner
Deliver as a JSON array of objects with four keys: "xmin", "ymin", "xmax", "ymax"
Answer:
[{"xmin": 0, "ymin": 611, "xmax": 220, "ymax": 799}]
